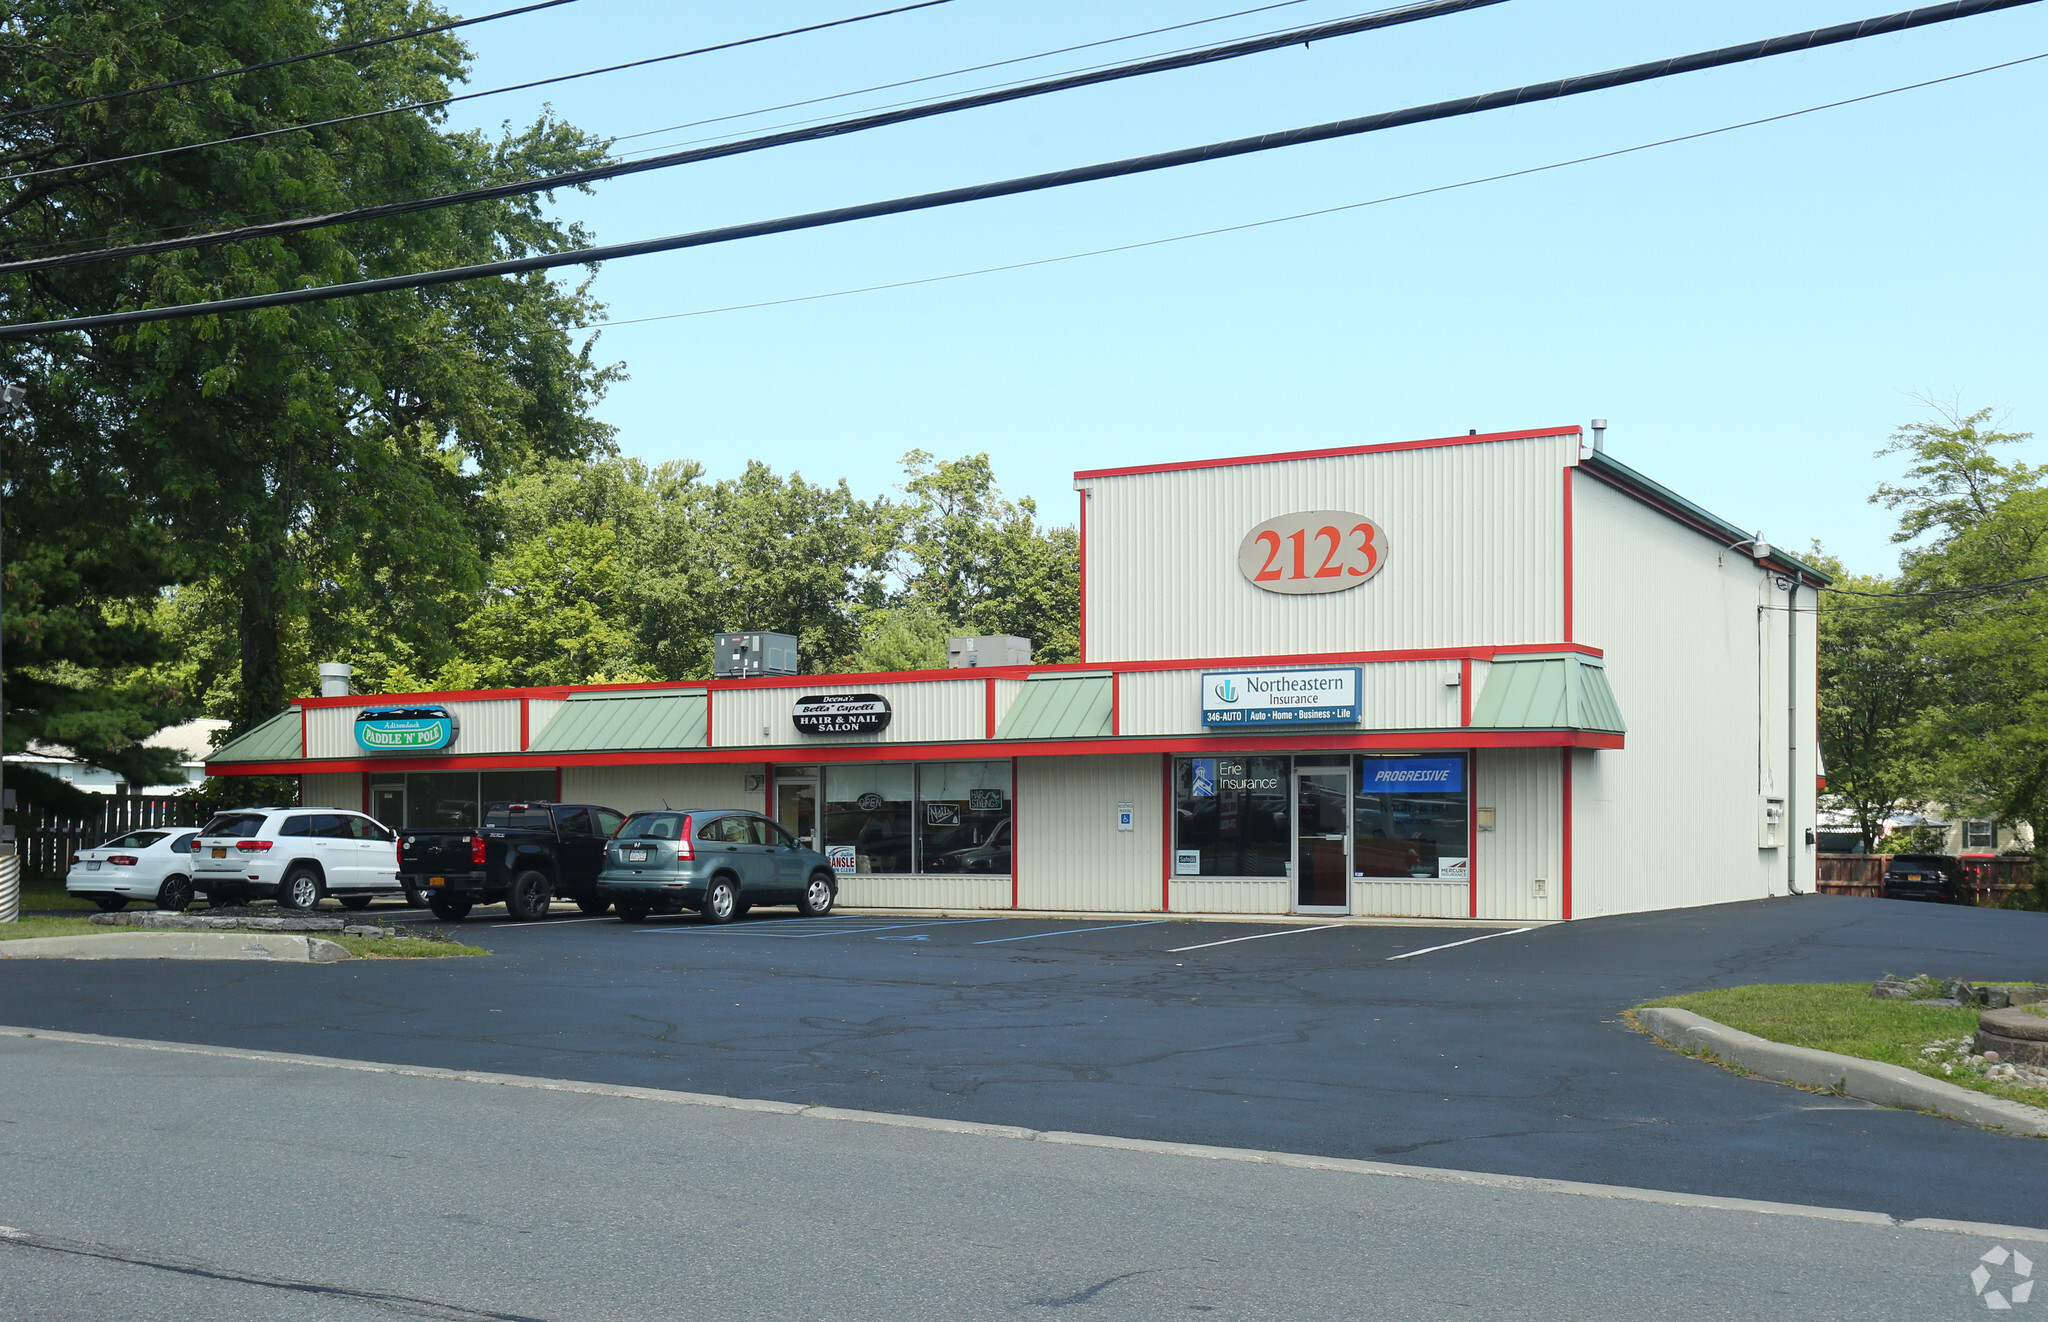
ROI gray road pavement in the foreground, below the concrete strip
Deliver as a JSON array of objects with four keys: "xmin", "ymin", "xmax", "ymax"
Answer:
[{"xmin": 0, "ymin": 1038, "xmax": 2023, "ymax": 1322}]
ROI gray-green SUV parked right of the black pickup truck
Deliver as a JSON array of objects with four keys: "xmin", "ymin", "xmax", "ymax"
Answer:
[{"xmin": 598, "ymin": 808, "xmax": 840, "ymax": 923}]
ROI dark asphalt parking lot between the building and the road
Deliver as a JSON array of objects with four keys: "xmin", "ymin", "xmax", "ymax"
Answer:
[{"xmin": 0, "ymin": 896, "xmax": 2048, "ymax": 1226}]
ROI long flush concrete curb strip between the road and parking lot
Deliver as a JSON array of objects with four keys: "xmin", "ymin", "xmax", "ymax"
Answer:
[{"xmin": 0, "ymin": 1025, "xmax": 2048, "ymax": 1244}]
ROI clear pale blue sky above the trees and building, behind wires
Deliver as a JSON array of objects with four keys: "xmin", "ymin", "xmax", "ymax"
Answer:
[{"xmin": 453, "ymin": 0, "xmax": 2048, "ymax": 571}]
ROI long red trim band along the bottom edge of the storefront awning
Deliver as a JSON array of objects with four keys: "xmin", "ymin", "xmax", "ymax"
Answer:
[{"xmin": 213, "ymin": 729, "xmax": 1626, "ymax": 776}]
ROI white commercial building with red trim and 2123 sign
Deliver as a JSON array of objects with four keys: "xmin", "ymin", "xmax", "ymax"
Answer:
[{"xmin": 207, "ymin": 428, "xmax": 1825, "ymax": 921}]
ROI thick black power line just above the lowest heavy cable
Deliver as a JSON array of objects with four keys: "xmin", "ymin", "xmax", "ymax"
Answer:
[{"xmin": 0, "ymin": 0, "xmax": 1507, "ymax": 274}]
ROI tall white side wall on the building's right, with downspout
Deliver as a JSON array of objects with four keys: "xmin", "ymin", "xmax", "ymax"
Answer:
[{"xmin": 1573, "ymin": 473, "xmax": 1815, "ymax": 917}]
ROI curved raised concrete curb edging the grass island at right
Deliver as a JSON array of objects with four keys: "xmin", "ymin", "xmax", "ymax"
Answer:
[{"xmin": 1636, "ymin": 1007, "xmax": 2048, "ymax": 1136}]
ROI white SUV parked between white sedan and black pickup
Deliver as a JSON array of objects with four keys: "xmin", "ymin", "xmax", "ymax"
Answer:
[{"xmin": 193, "ymin": 808, "xmax": 403, "ymax": 909}]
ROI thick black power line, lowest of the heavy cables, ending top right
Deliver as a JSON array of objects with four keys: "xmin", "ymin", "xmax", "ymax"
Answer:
[{"xmin": 0, "ymin": 0, "xmax": 2040, "ymax": 340}]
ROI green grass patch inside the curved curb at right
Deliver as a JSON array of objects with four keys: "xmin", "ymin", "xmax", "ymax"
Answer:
[{"xmin": 1636, "ymin": 982, "xmax": 2048, "ymax": 1107}]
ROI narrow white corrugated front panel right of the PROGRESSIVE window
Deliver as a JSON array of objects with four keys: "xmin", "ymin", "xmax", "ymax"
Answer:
[{"xmin": 1470, "ymin": 749, "xmax": 1556, "ymax": 919}]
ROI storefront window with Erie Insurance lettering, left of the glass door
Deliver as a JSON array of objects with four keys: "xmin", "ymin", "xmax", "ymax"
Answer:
[{"xmin": 1174, "ymin": 757, "xmax": 1292, "ymax": 876}]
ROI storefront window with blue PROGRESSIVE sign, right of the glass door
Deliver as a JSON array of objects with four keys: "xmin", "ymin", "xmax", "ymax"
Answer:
[{"xmin": 1352, "ymin": 757, "xmax": 1470, "ymax": 882}]
